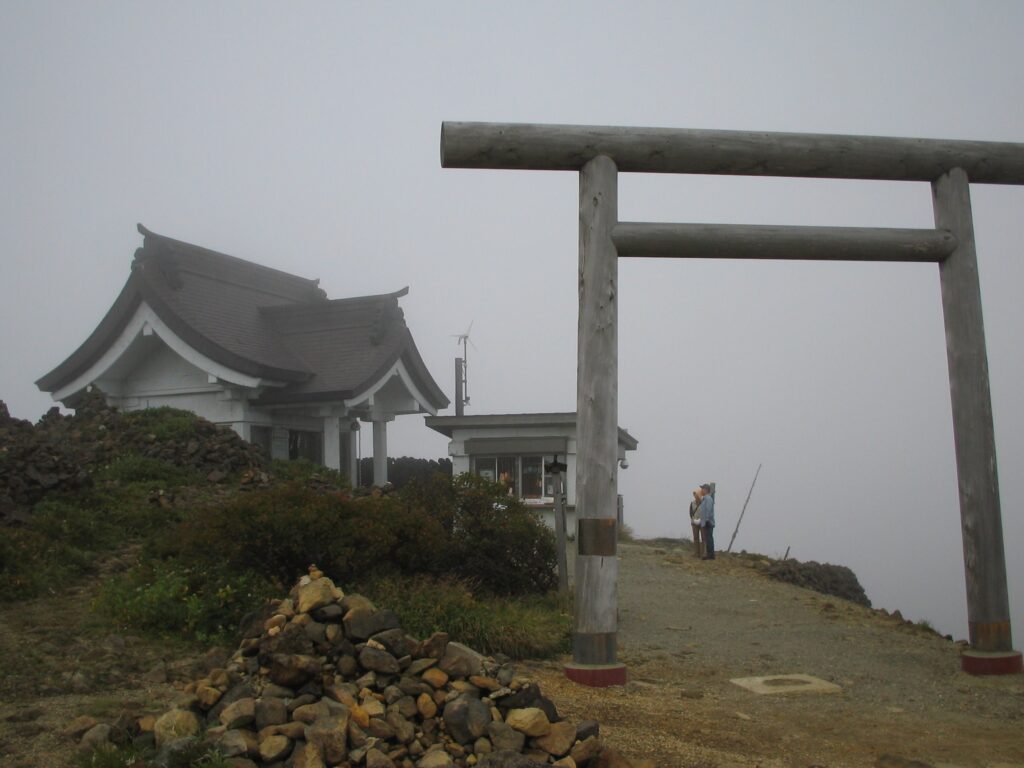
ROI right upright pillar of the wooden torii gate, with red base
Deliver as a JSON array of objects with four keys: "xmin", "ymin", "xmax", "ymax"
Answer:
[{"xmin": 932, "ymin": 168, "xmax": 1021, "ymax": 673}]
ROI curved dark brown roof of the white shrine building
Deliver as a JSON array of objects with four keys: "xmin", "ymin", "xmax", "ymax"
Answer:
[{"xmin": 36, "ymin": 224, "xmax": 447, "ymax": 409}]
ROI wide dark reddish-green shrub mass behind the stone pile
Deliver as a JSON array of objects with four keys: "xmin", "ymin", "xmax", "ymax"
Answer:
[{"xmin": 162, "ymin": 476, "xmax": 556, "ymax": 595}]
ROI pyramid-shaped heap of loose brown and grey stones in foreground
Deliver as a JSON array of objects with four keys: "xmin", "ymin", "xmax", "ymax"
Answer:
[{"xmin": 72, "ymin": 566, "xmax": 630, "ymax": 768}]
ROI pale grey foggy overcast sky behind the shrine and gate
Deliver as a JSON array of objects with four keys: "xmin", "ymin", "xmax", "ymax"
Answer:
[{"xmin": 0, "ymin": 0, "xmax": 1024, "ymax": 648}]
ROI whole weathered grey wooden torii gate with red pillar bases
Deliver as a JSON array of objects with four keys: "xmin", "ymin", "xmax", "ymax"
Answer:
[{"xmin": 441, "ymin": 122, "xmax": 1024, "ymax": 686}]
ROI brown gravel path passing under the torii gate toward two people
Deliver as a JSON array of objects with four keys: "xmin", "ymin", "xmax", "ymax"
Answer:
[{"xmin": 538, "ymin": 543, "xmax": 1024, "ymax": 768}]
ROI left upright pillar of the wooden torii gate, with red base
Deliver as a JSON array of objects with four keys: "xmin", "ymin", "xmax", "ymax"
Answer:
[{"xmin": 565, "ymin": 156, "xmax": 626, "ymax": 686}]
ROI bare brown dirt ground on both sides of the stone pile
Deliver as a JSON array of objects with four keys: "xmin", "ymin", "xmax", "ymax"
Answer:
[{"xmin": 0, "ymin": 543, "xmax": 1024, "ymax": 768}]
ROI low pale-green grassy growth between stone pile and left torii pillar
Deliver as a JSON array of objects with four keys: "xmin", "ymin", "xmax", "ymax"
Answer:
[{"xmin": 362, "ymin": 577, "xmax": 572, "ymax": 658}]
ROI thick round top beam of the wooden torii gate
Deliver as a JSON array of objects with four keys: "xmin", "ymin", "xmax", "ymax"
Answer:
[{"xmin": 440, "ymin": 121, "xmax": 1024, "ymax": 184}]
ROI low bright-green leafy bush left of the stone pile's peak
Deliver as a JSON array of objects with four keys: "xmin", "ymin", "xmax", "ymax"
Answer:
[{"xmin": 93, "ymin": 561, "xmax": 276, "ymax": 642}]
